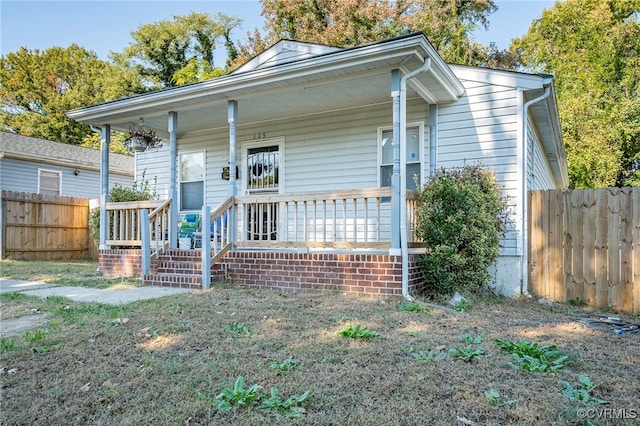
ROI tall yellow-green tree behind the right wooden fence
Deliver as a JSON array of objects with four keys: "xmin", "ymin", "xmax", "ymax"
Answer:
[{"xmin": 511, "ymin": 0, "xmax": 640, "ymax": 188}]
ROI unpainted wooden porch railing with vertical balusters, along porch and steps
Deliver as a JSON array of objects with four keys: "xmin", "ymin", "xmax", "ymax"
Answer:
[{"xmin": 106, "ymin": 188, "xmax": 419, "ymax": 253}]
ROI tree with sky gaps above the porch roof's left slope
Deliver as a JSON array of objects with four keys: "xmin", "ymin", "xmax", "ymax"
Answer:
[{"xmin": 112, "ymin": 12, "xmax": 242, "ymax": 88}]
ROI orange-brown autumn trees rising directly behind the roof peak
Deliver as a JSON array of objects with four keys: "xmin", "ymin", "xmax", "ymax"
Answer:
[{"xmin": 236, "ymin": 0, "xmax": 496, "ymax": 65}]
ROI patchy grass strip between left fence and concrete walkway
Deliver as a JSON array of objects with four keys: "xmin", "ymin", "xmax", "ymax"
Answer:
[{"xmin": 0, "ymin": 260, "xmax": 142, "ymax": 290}]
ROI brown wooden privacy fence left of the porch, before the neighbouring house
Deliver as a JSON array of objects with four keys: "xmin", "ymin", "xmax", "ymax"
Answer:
[{"xmin": 0, "ymin": 191, "xmax": 96, "ymax": 260}]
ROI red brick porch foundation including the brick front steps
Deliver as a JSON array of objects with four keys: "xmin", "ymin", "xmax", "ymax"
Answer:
[{"xmin": 100, "ymin": 250, "xmax": 422, "ymax": 296}]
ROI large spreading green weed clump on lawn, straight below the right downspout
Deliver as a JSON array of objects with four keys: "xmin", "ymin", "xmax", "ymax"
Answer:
[{"xmin": 496, "ymin": 339, "xmax": 569, "ymax": 373}]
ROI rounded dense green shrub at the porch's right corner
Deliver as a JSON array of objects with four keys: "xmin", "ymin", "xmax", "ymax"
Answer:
[{"xmin": 415, "ymin": 166, "xmax": 507, "ymax": 297}]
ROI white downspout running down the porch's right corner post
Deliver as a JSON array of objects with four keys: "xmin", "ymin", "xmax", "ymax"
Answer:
[{"xmin": 400, "ymin": 58, "xmax": 431, "ymax": 301}]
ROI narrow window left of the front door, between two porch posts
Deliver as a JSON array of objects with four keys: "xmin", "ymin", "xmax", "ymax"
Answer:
[{"xmin": 180, "ymin": 152, "xmax": 205, "ymax": 210}]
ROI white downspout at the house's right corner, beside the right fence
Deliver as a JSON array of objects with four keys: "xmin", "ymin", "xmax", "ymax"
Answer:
[{"xmin": 520, "ymin": 85, "xmax": 551, "ymax": 297}]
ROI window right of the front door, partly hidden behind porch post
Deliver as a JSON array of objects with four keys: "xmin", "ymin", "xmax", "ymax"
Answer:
[{"xmin": 378, "ymin": 125, "xmax": 422, "ymax": 191}]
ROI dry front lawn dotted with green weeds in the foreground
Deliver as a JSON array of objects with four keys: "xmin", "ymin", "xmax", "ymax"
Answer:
[{"xmin": 0, "ymin": 262, "xmax": 640, "ymax": 425}]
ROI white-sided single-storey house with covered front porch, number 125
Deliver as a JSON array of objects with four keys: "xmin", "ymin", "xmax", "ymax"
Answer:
[{"xmin": 67, "ymin": 33, "xmax": 568, "ymax": 298}]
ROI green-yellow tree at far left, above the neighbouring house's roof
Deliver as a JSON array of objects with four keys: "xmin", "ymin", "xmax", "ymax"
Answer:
[{"xmin": 0, "ymin": 44, "xmax": 144, "ymax": 145}]
